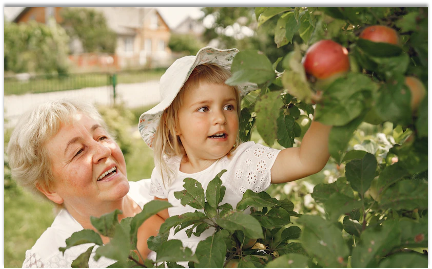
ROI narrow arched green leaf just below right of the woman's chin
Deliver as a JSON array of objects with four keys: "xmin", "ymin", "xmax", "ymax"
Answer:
[{"xmin": 130, "ymin": 200, "xmax": 172, "ymax": 247}]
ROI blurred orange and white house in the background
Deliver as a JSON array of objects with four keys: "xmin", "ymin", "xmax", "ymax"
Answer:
[{"xmin": 13, "ymin": 7, "xmax": 173, "ymax": 69}]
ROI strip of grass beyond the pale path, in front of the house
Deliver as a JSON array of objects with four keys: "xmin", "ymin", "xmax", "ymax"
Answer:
[{"xmin": 4, "ymin": 69, "xmax": 165, "ymax": 95}]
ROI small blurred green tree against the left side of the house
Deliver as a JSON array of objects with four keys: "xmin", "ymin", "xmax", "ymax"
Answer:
[{"xmin": 61, "ymin": 8, "xmax": 117, "ymax": 53}]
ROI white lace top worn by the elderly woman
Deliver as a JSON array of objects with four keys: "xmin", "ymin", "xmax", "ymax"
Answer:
[{"xmin": 22, "ymin": 179, "xmax": 156, "ymax": 268}]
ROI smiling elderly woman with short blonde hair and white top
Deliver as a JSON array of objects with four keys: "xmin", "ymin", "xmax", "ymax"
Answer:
[{"xmin": 7, "ymin": 100, "xmax": 163, "ymax": 267}]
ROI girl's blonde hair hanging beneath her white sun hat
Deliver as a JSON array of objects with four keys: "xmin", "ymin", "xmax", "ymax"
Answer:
[{"xmin": 153, "ymin": 64, "xmax": 240, "ymax": 186}]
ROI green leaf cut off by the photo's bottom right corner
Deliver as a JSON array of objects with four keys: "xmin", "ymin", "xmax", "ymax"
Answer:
[{"xmin": 378, "ymin": 252, "xmax": 429, "ymax": 268}]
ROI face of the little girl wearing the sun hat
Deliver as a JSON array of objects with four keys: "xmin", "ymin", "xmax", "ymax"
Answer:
[{"xmin": 176, "ymin": 82, "xmax": 239, "ymax": 160}]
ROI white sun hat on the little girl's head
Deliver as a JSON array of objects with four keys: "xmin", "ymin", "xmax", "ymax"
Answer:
[{"xmin": 138, "ymin": 47, "xmax": 258, "ymax": 148}]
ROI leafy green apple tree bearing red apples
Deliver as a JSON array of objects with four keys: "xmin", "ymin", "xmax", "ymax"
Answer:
[{"xmin": 62, "ymin": 7, "xmax": 428, "ymax": 268}]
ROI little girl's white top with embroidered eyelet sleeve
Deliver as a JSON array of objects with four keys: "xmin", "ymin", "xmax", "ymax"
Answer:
[{"xmin": 150, "ymin": 141, "xmax": 280, "ymax": 252}]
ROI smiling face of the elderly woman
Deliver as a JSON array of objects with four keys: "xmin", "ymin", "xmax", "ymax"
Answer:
[{"xmin": 45, "ymin": 113, "xmax": 129, "ymax": 215}]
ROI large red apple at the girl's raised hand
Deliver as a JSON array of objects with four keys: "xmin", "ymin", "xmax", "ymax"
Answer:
[{"xmin": 303, "ymin": 39, "xmax": 350, "ymax": 88}]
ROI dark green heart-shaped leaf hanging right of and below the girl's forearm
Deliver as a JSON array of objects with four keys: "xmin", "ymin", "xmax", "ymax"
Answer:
[{"xmin": 345, "ymin": 153, "xmax": 377, "ymax": 197}]
